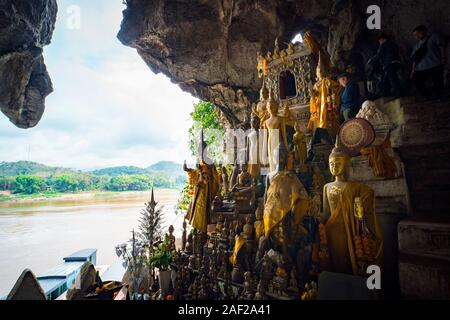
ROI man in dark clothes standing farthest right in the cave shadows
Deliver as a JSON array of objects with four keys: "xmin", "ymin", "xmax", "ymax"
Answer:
[{"xmin": 411, "ymin": 26, "xmax": 447, "ymax": 100}]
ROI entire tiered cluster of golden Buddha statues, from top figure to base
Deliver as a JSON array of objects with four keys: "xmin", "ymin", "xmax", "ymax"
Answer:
[{"xmin": 173, "ymin": 35, "xmax": 383, "ymax": 300}]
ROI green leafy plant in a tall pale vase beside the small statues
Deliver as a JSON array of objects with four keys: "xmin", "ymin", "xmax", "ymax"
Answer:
[{"xmin": 149, "ymin": 235, "xmax": 173, "ymax": 298}]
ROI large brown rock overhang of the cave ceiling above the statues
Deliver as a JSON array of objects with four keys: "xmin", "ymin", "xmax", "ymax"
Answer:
[{"xmin": 118, "ymin": 0, "xmax": 450, "ymax": 126}]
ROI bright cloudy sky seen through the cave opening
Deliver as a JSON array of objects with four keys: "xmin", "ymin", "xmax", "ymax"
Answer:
[{"xmin": 0, "ymin": 0, "xmax": 197, "ymax": 170}]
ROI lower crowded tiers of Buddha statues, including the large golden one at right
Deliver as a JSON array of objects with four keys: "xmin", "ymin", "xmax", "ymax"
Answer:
[{"xmin": 176, "ymin": 132, "xmax": 383, "ymax": 300}]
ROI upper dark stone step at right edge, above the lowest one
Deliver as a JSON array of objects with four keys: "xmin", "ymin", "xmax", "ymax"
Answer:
[{"xmin": 398, "ymin": 217, "xmax": 450, "ymax": 264}]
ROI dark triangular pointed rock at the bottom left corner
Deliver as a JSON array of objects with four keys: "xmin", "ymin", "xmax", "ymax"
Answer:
[{"xmin": 6, "ymin": 269, "xmax": 46, "ymax": 300}]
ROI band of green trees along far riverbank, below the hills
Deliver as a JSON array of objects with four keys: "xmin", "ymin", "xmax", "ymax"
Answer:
[{"xmin": 0, "ymin": 173, "xmax": 186, "ymax": 194}]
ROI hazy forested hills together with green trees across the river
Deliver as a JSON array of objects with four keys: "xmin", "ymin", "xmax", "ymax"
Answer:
[{"xmin": 0, "ymin": 161, "xmax": 186, "ymax": 194}]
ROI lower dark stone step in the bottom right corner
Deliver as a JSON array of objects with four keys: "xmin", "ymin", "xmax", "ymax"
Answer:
[{"xmin": 398, "ymin": 254, "xmax": 450, "ymax": 300}]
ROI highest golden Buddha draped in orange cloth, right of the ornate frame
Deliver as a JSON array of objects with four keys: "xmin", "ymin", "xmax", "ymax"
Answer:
[{"xmin": 308, "ymin": 53, "xmax": 341, "ymax": 136}]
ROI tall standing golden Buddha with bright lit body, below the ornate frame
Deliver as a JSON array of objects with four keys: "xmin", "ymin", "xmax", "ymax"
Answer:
[{"xmin": 264, "ymin": 93, "xmax": 288, "ymax": 171}]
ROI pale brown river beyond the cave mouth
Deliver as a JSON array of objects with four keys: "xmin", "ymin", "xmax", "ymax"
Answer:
[{"xmin": 0, "ymin": 190, "xmax": 182, "ymax": 297}]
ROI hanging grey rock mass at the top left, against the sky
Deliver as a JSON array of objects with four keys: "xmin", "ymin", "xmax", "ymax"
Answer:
[{"xmin": 0, "ymin": 0, "xmax": 57, "ymax": 128}]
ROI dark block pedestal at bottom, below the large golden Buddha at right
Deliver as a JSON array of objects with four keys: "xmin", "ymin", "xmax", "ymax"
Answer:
[{"xmin": 318, "ymin": 271, "xmax": 378, "ymax": 300}]
